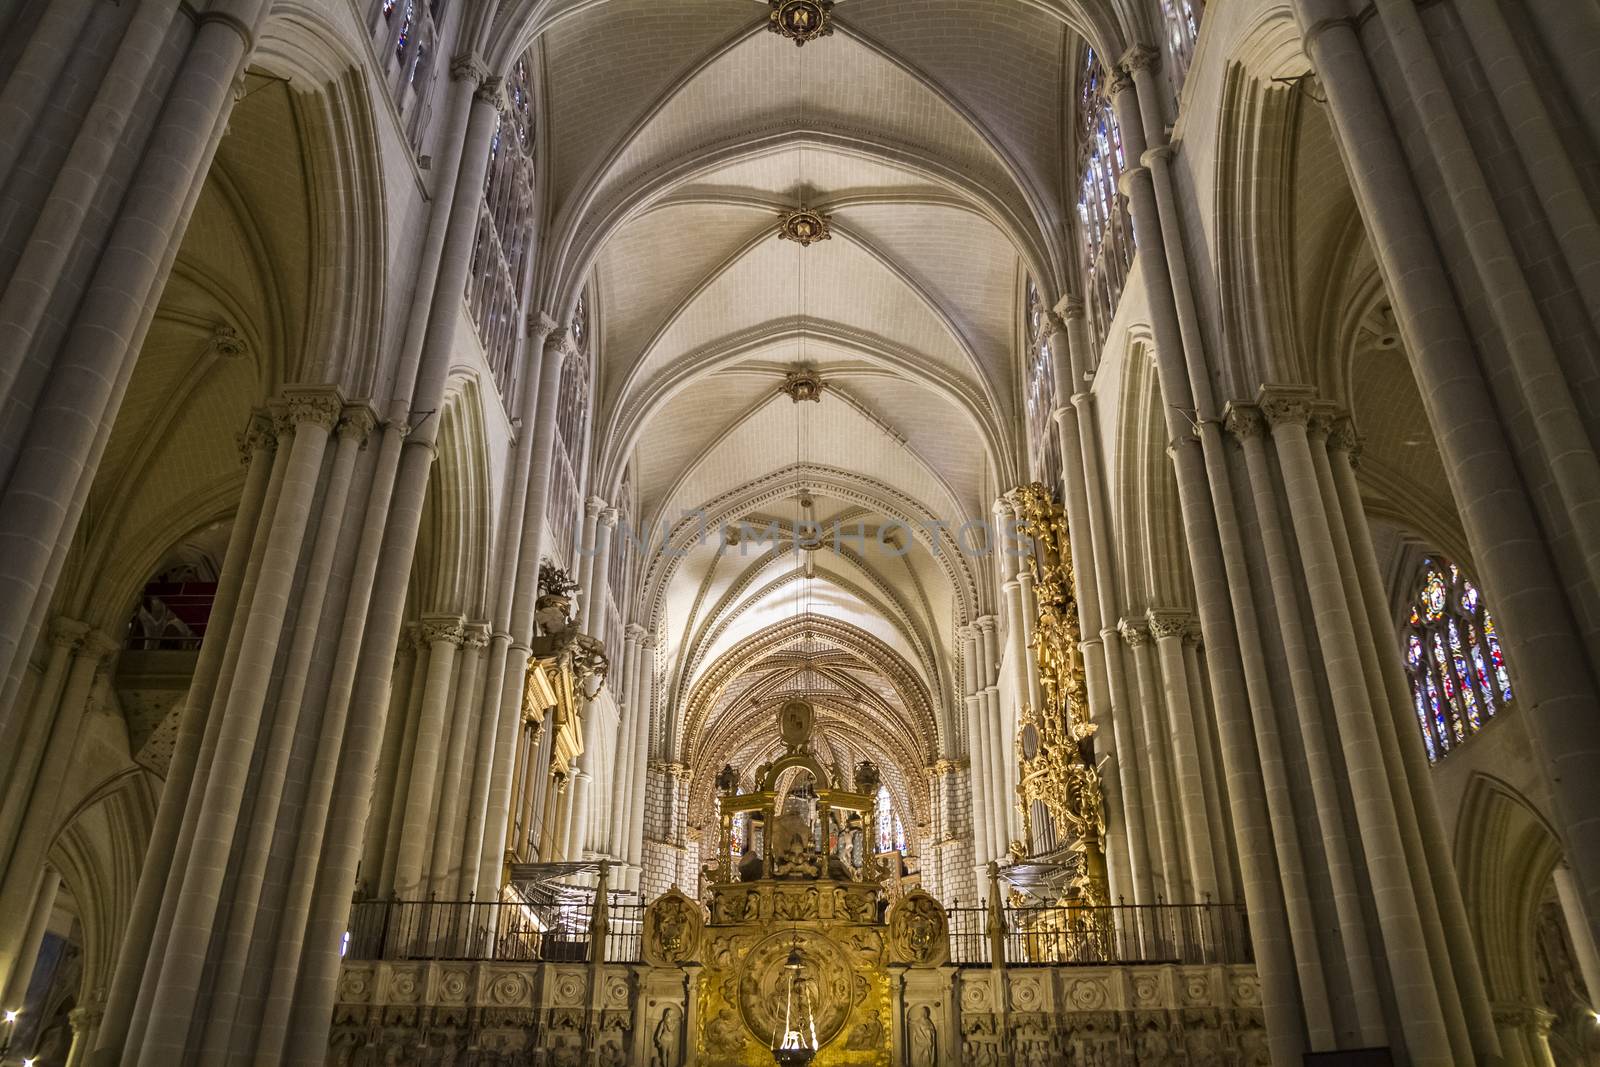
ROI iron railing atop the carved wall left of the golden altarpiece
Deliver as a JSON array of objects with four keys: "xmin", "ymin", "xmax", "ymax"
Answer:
[{"xmin": 344, "ymin": 894, "xmax": 645, "ymax": 963}]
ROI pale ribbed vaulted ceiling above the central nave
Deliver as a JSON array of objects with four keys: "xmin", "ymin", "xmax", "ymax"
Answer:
[{"xmin": 496, "ymin": 0, "xmax": 1100, "ymax": 812}]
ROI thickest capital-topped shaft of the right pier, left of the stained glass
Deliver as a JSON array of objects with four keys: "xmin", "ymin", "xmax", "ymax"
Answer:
[{"xmin": 1261, "ymin": 394, "xmax": 1472, "ymax": 1067}]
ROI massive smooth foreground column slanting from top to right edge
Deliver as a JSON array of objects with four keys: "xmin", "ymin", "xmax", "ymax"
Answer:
[{"xmin": 1294, "ymin": 0, "xmax": 1600, "ymax": 959}]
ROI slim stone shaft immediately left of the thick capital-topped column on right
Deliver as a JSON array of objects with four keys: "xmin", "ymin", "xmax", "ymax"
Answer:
[{"xmin": 1227, "ymin": 405, "xmax": 1386, "ymax": 1048}]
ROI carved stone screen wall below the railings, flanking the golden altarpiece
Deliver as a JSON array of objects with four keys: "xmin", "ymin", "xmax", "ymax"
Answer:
[{"xmin": 328, "ymin": 961, "xmax": 1269, "ymax": 1067}]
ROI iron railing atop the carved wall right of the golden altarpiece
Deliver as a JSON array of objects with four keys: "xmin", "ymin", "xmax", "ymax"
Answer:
[{"xmin": 949, "ymin": 904, "xmax": 1254, "ymax": 966}]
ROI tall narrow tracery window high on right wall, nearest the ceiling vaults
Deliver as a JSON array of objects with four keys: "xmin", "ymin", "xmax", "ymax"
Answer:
[{"xmin": 1077, "ymin": 48, "xmax": 1133, "ymax": 346}]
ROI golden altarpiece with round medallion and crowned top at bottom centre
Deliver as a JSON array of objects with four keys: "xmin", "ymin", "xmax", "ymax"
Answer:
[{"xmin": 645, "ymin": 701, "xmax": 949, "ymax": 1067}]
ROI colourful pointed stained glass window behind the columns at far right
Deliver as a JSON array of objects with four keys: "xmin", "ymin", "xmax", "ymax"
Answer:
[{"xmin": 1402, "ymin": 557, "xmax": 1512, "ymax": 761}]
